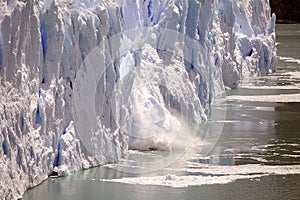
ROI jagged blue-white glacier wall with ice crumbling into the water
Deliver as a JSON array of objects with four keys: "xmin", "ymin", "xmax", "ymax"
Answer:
[{"xmin": 0, "ymin": 0, "xmax": 277, "ymax": 199}]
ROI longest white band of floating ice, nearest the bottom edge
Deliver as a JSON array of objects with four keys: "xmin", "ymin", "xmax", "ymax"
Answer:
[{"xmin": 101, "ymin": 163, "xmax": 300, "ymax": 188}]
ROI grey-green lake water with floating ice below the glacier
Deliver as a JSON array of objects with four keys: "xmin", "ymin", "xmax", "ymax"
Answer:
[{"xmin": 23, "ymin": 25, "xmax": 300, "ymax": 200}]
